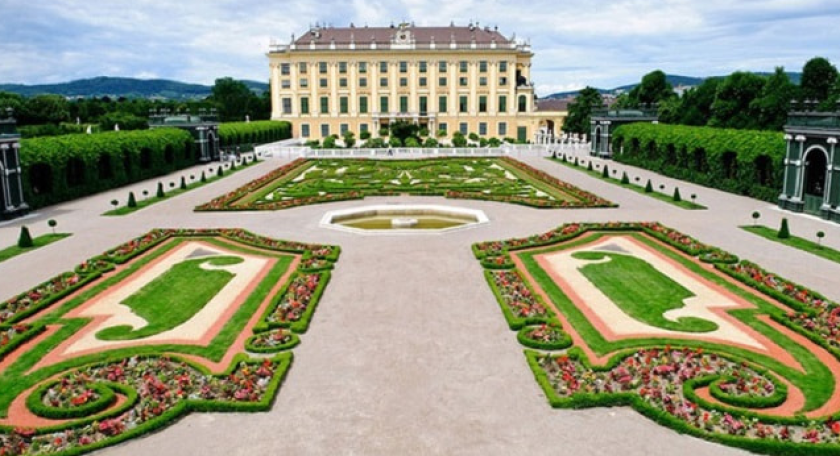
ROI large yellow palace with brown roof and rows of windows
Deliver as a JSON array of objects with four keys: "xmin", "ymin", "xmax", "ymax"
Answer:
[{"xmin": 268, "ymin": 24, "xmax": 565, "ymax": 141}]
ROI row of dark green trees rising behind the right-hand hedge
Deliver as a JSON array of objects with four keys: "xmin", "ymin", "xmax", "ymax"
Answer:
[{"xmin": 563, "ymin": 57, "xmax": 840, "ymax": 134}]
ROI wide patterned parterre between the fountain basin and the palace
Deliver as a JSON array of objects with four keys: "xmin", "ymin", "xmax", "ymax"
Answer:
[{"xmin": 196, "ymin": 157, "xmax": 613, "ymax": 211}]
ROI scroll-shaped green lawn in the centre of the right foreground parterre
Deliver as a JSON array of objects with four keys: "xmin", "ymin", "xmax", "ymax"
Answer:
[{"xmin": 573, "ymin": 252, "xmax": 718, "ymax": 332}]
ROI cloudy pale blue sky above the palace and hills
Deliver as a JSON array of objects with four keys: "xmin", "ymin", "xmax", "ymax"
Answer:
[{"xmin": 0, "ymin": 0, "xmax": 840, "ymax": 96}]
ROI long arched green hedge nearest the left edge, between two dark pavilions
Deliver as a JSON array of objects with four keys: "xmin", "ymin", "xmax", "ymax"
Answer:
[{"xmin": 20, "ymin": 128, "xmax": 195, "ymax": 207}]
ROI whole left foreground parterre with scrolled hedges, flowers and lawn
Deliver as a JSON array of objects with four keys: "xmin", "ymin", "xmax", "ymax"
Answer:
[{"xmin": 0, "ymin": 229, "xmax": 339, "ymax": 455}]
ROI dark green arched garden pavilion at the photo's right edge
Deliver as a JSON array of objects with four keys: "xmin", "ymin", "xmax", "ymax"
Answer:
[{"xmin": 779, "ymin": 102, "xmax": 840, "ymax": 221}]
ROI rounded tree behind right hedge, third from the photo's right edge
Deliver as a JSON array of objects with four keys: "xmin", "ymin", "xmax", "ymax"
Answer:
[{"xmin": 709, "ymin": 71, "xmax": 765, "ymax": 130}]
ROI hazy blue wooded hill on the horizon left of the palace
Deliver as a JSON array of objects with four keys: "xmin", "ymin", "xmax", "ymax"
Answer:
[{"xmin": 0, "ymin": 76, "xmax": 268, "ymax": 100}]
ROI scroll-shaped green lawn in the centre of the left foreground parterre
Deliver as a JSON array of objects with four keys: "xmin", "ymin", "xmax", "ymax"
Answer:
[{"xmin": 96, "ymin": 256, "xmax": 243, "ymax": 340}]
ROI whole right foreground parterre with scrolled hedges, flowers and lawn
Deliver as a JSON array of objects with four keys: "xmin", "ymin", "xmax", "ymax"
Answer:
[{"xmin": 473, "ymin": 223, "xmax": 840, "ymax": 455}]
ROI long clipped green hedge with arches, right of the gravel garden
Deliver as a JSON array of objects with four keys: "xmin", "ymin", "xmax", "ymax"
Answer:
[{"xmin": 613, "ymin": 123, "xmax": 785, "ymax": 201}]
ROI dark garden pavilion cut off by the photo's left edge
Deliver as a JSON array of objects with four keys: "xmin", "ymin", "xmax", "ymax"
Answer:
[{"xmin": 0, "ymin": 110, "xmax": 29, "ymax": 219}]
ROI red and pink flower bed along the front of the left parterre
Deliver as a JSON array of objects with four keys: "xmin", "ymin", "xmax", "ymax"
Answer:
[{"xmin": 0, "ymin": 357, "xmax": 289, "ymax": 455}]
